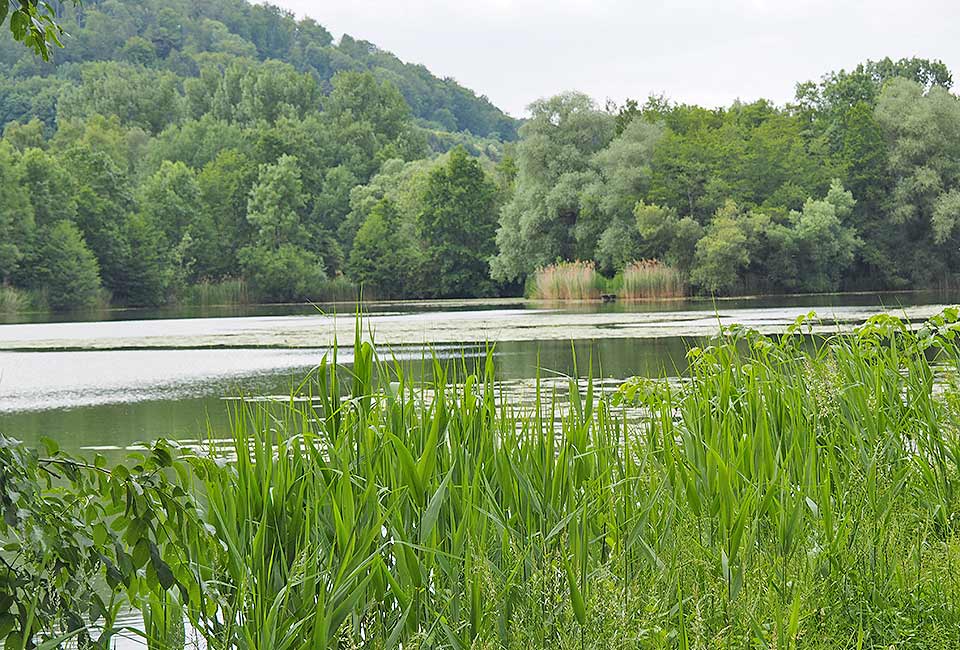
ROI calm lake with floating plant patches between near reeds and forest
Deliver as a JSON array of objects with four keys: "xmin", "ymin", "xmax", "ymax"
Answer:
[{"xmin": 0, "ymin": 292, "xmax": 958, "ymax": 453}]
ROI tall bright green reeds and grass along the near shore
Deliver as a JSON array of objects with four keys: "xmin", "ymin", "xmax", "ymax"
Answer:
[{"xmin": 144, "ymin": 310, "xmax": 960, "ymax": 648}]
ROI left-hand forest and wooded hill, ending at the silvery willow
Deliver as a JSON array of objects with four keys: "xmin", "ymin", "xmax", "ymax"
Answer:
[{"xmin": 0, "ymin": 0, "xmax": 516, "ymax": 309}]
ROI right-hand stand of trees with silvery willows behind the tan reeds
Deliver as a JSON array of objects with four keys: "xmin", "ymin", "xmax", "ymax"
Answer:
[{"xmin": 492, "ymin": 59, "xmax": 960, "ymax": 293}]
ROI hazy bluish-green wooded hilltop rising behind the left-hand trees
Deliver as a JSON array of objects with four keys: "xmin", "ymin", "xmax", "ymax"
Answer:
[{"xmin": 0, "ymin": 0, "xmax": 518, "ymax": 140}]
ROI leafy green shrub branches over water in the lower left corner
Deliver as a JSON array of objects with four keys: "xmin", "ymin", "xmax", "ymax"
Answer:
[{"xmin": 0, "ymin": 436, "xmax": 207, "ymax": 648}]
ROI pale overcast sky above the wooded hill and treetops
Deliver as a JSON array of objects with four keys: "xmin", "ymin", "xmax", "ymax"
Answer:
[{"xmin": 273, "ymin": 0, "xmax": 960, "ymax": 117}]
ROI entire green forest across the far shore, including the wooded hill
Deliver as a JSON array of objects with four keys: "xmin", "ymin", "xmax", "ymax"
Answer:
[{"xmin": 0, "ymin": 0, "xmax": 960, "ymax": 309}]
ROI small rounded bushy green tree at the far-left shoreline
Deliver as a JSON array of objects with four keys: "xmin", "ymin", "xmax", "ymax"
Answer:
[{"xmin": 34, "ymin": 220, "xmax": 100, "ymax": 310}]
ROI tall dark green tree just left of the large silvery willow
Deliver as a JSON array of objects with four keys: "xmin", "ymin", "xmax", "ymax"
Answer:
[{"xmin": 417, "ymin": 147, "xmax": 497, "ymax": 298}]
